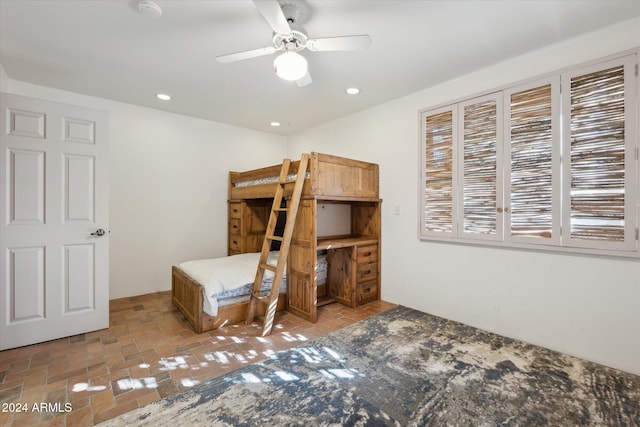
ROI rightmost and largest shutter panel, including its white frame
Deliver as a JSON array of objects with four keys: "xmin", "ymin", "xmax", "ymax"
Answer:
[{"xmin": 563, "ymin": 57, "xmax": 635, "ymax": 248}]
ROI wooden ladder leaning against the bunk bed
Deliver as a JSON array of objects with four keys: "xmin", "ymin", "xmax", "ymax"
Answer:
[{"xmin": 245, "ymin": 153, "xmax": 309, "ymax": 336}]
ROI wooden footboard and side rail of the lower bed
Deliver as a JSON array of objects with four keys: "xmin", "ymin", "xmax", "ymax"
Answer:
[{"xmin": 171, "ymin": 266, "xmax": 286, "ymax": 333}]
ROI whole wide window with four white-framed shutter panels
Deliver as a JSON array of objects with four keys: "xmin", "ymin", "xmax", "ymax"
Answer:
[{"xmin": 420, "ymin": 55, "xmax": 639, "ymax": 256}]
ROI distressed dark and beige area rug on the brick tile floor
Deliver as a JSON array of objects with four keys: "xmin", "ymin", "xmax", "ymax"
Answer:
[{"xmin": 101, "ymin": 307, "xmax": 640, "ymax": 427}]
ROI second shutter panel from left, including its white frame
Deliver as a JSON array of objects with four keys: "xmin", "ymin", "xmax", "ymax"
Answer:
[{"xmin": 460, "ymin": 94, "xmax": 503, "ymax": 239}]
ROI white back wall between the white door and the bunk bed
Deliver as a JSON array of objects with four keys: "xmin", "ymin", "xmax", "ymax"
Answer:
[{"xmin": 8, "ymin": 80, "xmax": 286, "ymax": 299}]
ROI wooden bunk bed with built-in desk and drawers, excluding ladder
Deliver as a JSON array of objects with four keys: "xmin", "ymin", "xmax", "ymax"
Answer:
[{"xmin": 172, "ymin": 152, "xmax": 382, "ymax": 332}]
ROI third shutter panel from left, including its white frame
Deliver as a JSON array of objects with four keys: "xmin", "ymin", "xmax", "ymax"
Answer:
[{"xmin": 505, "ymin": 77, "xmax": 560, "ymax": 244}]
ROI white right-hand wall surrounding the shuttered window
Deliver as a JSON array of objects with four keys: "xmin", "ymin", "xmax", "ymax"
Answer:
[{"xmin": 288, "ymin": 19, "xmax": 640, "ymax": 374}]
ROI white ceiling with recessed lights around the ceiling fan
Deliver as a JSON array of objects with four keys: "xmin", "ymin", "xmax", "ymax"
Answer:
[{"xmin": 0, "ymin": 0, "xmax": 640, "ymax": 134}]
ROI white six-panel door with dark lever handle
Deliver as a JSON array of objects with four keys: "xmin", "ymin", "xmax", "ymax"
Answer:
[{"xmin": 0, "ymin": 93, "xmax": 109, "ymax": 350}]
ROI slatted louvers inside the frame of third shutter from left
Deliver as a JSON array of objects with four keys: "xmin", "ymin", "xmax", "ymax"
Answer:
[{"xmin": 509, "ymin": 84, "xmax": 553, "ymax": 238}]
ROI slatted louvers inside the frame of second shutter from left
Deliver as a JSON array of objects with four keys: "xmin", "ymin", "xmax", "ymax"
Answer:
[{"xmin": 463, "ymin": 100, "xmax": 497, "ymax": 235}]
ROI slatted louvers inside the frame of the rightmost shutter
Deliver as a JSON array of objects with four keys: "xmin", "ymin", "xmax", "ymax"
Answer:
[{"xmin": 570, "ymin": 66, "xmax": 625, "ymax": 242}]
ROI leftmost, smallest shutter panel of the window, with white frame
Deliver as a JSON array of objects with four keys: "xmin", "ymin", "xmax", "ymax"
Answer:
[{"xmin": 421, "ymin": 106, "xmax": 456, "ymax": 235}]
